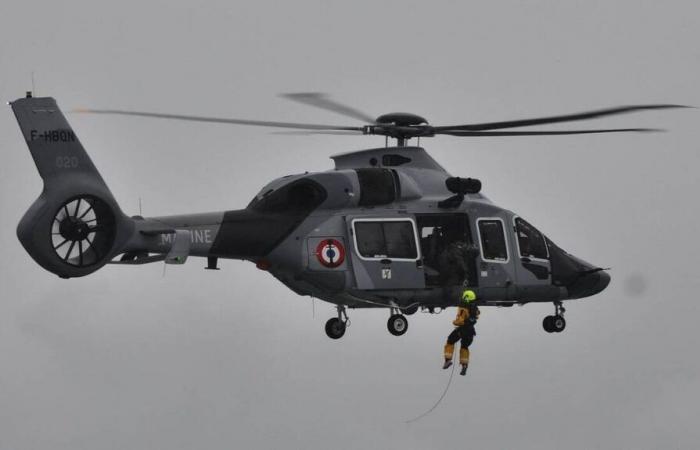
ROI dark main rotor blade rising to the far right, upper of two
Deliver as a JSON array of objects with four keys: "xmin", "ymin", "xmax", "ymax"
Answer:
[{"xmin": 435, "ymin": 105, "xmax": 688, "ymax": 131}]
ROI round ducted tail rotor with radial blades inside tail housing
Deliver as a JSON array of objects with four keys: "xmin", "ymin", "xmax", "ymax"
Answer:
[{"xmin": 51, "ymin": 195, "xmax": 116, "ymax": 267}]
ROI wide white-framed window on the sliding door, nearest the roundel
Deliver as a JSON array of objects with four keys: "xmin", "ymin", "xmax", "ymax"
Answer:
[{"xmin": 353, "ymin": 220, "xmax": 418, "ymax": 260}]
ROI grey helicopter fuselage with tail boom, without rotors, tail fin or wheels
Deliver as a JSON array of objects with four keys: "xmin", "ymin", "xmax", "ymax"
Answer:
[{"xmin": 128, "ymin": 147, "xmax": 610, "ymax": 308}]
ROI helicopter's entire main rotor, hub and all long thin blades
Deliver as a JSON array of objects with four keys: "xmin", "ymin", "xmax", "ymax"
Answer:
[{"xmin": 75, "ymin": 92, "xmax": 686, "ymax": 146}]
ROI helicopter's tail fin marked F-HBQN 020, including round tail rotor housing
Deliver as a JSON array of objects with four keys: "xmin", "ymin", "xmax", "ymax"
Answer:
[{"xmin": 10, "ymin": 95, "xmax": 133, "ymax": 278}]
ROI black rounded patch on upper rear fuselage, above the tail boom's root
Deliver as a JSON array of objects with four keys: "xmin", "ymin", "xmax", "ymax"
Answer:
[{"xmin": 248, "ymin": 179, "xmax": 328, "ymax": 214}]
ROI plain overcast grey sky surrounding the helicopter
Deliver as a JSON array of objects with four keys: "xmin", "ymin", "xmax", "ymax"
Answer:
[{"xmin": 0, "ymin": 0, "xmax": 700, "ymax": 450}]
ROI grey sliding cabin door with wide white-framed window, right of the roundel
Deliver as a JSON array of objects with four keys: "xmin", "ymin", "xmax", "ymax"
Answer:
[{"xmin": 347, "ymin": 216, "xmax": 425, "ymax": 290}]
